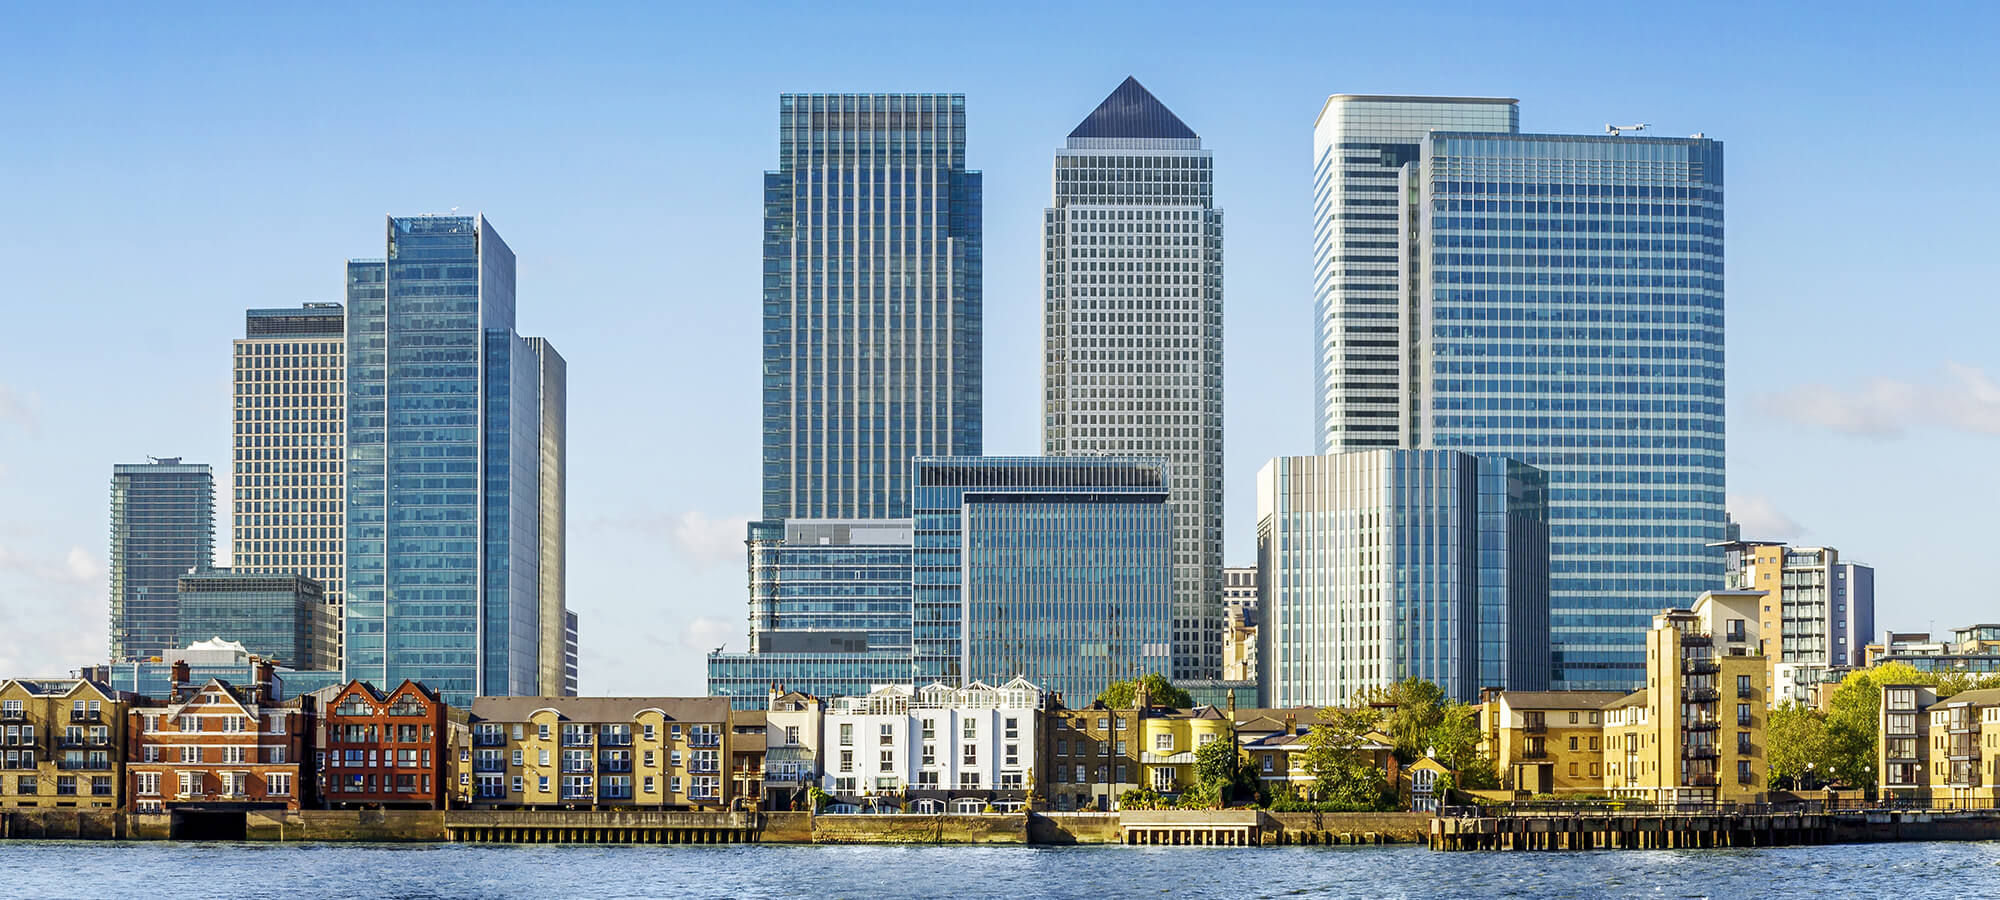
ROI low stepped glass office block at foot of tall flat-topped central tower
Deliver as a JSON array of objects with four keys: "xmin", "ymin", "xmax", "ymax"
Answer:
[{"xmin": 708, "ymin": 518, "xmax": 914, "ymax": 708}]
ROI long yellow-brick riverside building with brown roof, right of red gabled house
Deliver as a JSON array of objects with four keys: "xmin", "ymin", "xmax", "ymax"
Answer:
[{"xmin": 472, "ymin": 696, "xmax": 764, "ymax": 810}]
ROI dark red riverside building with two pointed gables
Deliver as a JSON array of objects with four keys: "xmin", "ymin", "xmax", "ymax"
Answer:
[{"xmin": 316, "ymin": 680, "xmax": 472, "ymax": 810}]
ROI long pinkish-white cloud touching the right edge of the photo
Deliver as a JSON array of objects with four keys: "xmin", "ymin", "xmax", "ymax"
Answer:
[{"xmin": 1754, "ymin": 362, "xmax": 2000, "ymax": 438}]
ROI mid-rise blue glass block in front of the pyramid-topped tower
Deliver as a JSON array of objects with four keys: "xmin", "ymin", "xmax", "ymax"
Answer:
[{"xmin": 912, "ymin": 456, "xmax": 1176, "ymax": 698}]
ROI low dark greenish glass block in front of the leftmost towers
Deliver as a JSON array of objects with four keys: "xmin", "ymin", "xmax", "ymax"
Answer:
[{"xmin": 178, "ymin": 568, "xmax": 340, "ymax": 672}]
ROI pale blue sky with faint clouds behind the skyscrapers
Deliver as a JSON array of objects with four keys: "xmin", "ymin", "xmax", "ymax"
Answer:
[{"xmin": 0, "ymin": 2, "xmax": 2000, "ymax": 696}]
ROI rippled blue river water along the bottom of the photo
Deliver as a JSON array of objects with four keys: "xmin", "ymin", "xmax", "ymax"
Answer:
[{"xmin": 0, "ymin": 840, "xmax": 2000, "ymax": 900}]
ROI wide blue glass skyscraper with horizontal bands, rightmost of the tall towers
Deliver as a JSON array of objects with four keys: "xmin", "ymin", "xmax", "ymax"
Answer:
[{"xmin": 1414, "ymin": 132, "xmax": 1724, "ymax": 688}]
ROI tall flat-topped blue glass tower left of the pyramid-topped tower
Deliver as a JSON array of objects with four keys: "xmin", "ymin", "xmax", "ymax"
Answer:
[{"xmin": 762, "ymin": 94, "xmax": 982, "ymax": 522}]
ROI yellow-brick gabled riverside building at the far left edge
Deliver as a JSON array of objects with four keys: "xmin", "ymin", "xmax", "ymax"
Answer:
[{"xmin": 0, "ymin": 678, "xmax": 126, "ymax": 810}]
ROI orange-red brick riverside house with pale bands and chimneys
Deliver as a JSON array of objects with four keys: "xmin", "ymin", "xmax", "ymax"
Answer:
[{"xmin": 126, "ymin": 662, "xmax": 312, "ymax": 812}]
